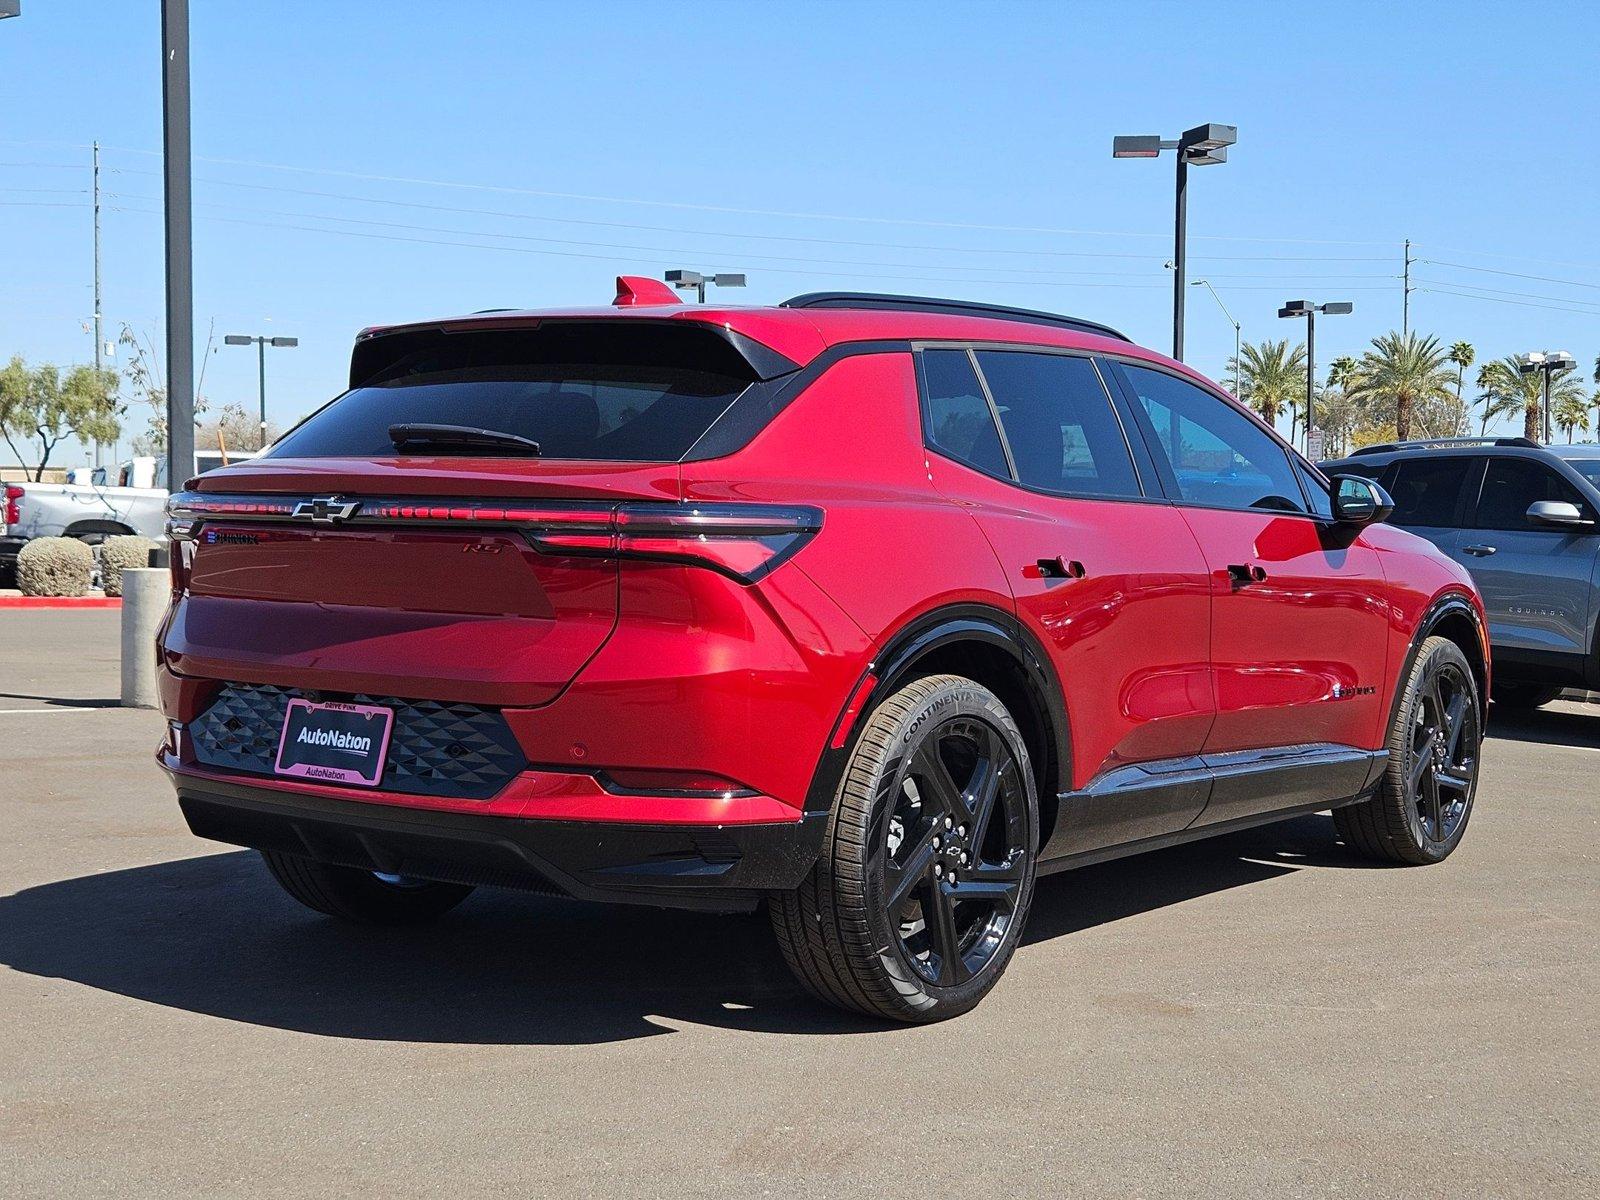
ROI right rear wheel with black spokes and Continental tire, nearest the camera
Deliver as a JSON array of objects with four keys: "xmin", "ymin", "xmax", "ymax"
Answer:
[{"xmin": 768, "ymin": 675, "xmax": 1038, "ymax": 1022}]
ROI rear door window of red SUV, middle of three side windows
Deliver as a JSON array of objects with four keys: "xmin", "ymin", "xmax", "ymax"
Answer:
[{"xmin": 978, "ymin": 350, "xmax": 1141, "ymax": 496}]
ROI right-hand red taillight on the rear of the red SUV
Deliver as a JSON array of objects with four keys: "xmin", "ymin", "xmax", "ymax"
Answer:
[{"xmin": 533, "ymin": 504, "xmax": 822, "ymax": 582}]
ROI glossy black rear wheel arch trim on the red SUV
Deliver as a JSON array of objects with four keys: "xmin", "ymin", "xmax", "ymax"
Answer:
[{"xmin": 806, "ymin": 605, "xmax": 1072, "ymax": 845}]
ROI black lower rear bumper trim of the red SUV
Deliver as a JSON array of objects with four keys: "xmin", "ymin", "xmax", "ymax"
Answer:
[{"xmin": 174, "ymin": 776, "xmax": 826, "ymax": 910}]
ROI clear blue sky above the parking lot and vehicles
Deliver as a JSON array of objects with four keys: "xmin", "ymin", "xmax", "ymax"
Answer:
[{"xmin": 0, "ymin": 0, "xmax": 1600, "ymax": 464}]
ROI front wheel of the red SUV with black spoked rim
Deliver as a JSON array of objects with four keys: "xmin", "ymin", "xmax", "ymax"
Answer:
[{"xmin": 1333, "ymin": 637, "xmax": 1483, "ymax": 866}]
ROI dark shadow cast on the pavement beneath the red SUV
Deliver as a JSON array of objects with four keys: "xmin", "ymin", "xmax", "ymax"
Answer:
[{"xmin": 0, "ymin": 816, "xmax": 1357, "ymax": 1045}]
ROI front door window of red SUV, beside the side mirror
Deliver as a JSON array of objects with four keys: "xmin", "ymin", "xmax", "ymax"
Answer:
[{"xmin": 1123, "ymin": 365, "xmax": 1306, "ymax": 512}]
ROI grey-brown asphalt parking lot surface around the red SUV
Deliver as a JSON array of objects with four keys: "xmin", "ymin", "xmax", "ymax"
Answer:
[{"xmin": 0, "ymin": 611, "xmax": 1600, "ymax": 1197}]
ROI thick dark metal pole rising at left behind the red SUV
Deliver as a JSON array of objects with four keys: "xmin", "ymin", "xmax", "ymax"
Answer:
[{"xmin": 162, "ymin": 0, "xmax": 195, "ymax": 491}]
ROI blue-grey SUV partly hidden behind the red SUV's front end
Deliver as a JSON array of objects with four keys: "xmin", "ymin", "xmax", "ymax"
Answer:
[{"xmin": 1322, "ymin": 437, "xmax": 1600, "ymax": 707}]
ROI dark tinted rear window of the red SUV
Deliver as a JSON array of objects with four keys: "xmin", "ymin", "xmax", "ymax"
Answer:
[{"xmin": 267, "ymin": 322, "xmax": 755, "ymax": 462}]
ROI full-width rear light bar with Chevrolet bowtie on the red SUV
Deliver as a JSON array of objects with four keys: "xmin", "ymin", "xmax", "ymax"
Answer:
[{"xmin": 166, "ymin": 491, "xmax": 822, "ymax": 582}]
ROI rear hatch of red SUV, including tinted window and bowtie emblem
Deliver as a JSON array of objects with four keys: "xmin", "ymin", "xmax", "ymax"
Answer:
[{"xmin": 165, "ymin": 320, "xmax": 780, "ymax": 706}]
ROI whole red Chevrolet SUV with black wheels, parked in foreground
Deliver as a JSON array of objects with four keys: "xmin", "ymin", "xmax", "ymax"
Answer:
[{"xmin": 160, "ymin": 278, "xmax": 1490, "ymax": 1021}]
